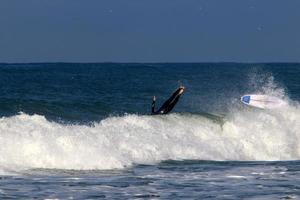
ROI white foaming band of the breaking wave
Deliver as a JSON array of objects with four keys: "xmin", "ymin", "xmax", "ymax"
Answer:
[{"xmin": 0, "ymin": 101, "xmax": 300, "ymax": 170}]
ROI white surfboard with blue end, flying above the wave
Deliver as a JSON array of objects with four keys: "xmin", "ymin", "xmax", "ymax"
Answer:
[{"xmin": 241, "ymin": 94, "xmax": 287, "ymax": 109}]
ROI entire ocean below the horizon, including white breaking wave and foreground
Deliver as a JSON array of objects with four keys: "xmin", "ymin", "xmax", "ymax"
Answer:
[{"xmin": 0, "ymin": 63, "xmax": 300, "ymax": 199}]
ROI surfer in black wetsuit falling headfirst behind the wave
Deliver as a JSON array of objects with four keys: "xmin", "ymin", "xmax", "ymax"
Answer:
[{"xmin": 151, "ymin": 86, "xmax": 185, "ymax": 115}]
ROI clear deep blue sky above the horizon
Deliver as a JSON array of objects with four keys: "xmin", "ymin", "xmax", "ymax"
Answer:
[{"xmin": 0, "ymin": 0, "xmax": 300, "ymax": 62}]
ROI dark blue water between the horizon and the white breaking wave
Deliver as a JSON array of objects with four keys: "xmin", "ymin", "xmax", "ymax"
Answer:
[{"xmin": 0, "ymin": 63, "xmax": 300, "ymax": 123}]
